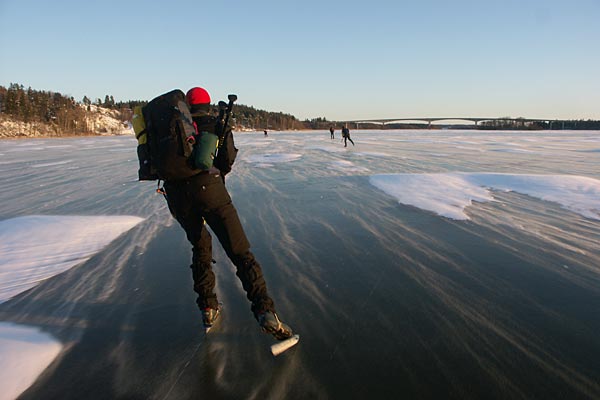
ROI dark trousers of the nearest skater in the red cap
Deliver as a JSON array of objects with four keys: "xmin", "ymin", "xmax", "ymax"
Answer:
[{"xmin": 165, "ymin": 171, "xmax": 275, "ymax": 315}]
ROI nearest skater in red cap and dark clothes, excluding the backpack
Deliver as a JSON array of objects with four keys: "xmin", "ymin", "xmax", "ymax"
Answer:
[{"xmin": 164, "ymin": 87, "xmax": 292, "ymax": 340}]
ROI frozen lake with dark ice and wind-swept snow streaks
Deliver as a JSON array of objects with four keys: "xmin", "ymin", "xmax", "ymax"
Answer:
[{"xmin": 0, "ymin": 130, "xmax": 600, "ymax": 399}]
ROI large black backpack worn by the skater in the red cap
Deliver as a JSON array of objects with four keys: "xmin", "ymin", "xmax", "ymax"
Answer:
[{"xmin": 132, "ymin": 89, "xmax": 201, "ymax": 181}]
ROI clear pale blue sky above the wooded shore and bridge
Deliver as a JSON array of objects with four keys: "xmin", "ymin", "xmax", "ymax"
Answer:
[{"xmin": 0, "ymin": 0, "xmax": 600, "ymax": 120}]
